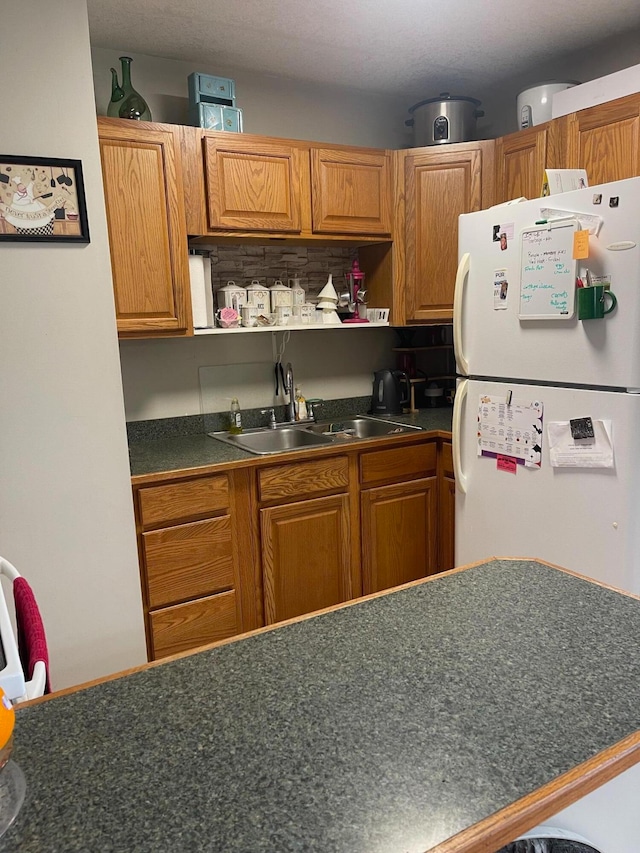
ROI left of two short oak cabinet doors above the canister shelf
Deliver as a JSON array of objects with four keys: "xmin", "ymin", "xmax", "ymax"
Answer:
[{"xmin": 204, "ymin": 134, "xmax": 308, "ymax": 233}]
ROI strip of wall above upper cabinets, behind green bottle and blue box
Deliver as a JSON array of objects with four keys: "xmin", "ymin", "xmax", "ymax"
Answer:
[{"xmin": 91, "ymin": 45, "xmax": 413, "ymax": 148}]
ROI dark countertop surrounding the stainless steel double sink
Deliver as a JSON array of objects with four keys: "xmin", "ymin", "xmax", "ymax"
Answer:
[{"xmin": 129, "ymin": 408, "xmax": 452, "ymax": 476}]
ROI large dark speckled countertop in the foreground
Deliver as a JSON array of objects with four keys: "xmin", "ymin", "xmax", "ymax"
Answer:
[{"xmin": 7, "ymin": 560, "xmax": 640, "ymax": 853}]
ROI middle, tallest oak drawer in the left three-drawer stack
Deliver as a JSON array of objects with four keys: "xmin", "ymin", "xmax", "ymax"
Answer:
[{"xmin": 142, "ymin": 515, "xmax": 233, "ymax": 607}]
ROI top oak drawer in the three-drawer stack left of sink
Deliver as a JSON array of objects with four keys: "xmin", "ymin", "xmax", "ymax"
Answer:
[{"xmin": 138, "ymin": 475, "xmax": 229, "ymax": 527}]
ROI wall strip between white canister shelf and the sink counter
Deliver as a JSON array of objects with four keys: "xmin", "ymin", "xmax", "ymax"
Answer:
[{"xmin": 120, "ymin": 328, "xmax": 395, "ymax": 421}]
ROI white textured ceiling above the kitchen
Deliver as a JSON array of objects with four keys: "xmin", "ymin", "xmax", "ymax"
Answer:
[{"xmin": 87, "ymin": 0, "xmax": 640, "ymax": 94}]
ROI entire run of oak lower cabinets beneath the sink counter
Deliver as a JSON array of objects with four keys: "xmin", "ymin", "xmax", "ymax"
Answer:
[{"xmin": 134, "ymin": 437, "xmax": 454, "ymax": 660}]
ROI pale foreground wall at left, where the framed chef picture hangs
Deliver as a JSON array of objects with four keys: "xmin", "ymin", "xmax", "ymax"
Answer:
[{"xmin": 0, "ymin": 0, "xmax": 146, "ymax": 688}]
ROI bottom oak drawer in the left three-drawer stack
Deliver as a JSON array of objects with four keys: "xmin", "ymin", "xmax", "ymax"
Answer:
[{"xmin": 150, "ymin": 590, "xmax": 240, "ymax": 659}]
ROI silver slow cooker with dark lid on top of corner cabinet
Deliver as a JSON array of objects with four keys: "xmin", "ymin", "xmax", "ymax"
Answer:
[{"xmin": 405, "ymin": 92, "xmax": 484, "ymax": 148}]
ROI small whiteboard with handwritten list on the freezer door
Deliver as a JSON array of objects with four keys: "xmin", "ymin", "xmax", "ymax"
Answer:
[{"xmin": 519, "ymin": 220, "xmax": 578, "ymax": 320}]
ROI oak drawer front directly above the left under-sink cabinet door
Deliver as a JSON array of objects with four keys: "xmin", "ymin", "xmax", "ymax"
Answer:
[{"xmin": 258, "ymin": 456, "xmax": 349, "ymax": 501}]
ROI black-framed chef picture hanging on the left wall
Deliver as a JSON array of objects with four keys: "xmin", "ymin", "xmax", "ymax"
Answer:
[{"xmin": 0, "ymin": 154, "xmax": 89, "ymax": 243}]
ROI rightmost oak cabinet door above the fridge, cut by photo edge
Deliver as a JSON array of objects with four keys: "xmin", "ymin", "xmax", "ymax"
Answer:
[{"xmin": 567, "ymin": 95, "xmax": 640, "ymax": 186}]
